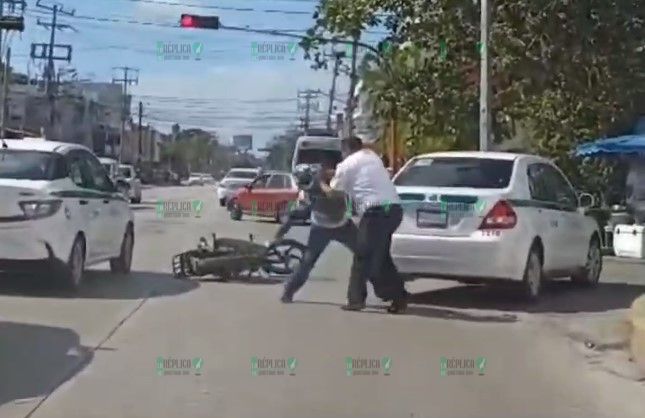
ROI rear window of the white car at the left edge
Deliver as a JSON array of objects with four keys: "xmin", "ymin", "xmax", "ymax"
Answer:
[{"xmin": 0, "ymin": 149, "xmax": 67, "ymax": 180}]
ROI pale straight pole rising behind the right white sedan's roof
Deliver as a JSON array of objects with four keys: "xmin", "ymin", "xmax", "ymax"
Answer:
[{"xmin": 479, "ymin": 0, "xmax": 491, "ymax": 151}]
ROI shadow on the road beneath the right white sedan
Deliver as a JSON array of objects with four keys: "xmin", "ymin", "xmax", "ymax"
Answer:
[{"xmin": 410, "ymin": 281, "xmax": 645, "ymax": 313}]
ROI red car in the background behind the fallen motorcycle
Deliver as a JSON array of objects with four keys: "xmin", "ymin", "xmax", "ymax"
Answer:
[{"xmin": 228, "ymin": 171, "xmax": 298, "ymax": 222}]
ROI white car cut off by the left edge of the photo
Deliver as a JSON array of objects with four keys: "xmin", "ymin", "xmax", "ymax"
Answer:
[{"xmin": 0, "ymin": 138, "xmax": 134, "ymax": 288}]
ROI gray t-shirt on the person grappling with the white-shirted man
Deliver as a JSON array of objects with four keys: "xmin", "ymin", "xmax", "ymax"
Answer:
[{"xmin": 305, "ymin": 178, "xmax": 351, "ymax": 228}]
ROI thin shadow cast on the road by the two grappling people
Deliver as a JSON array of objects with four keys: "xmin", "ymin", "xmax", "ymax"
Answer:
[{"xmin": 294, "ymin": 301, "xmax": 517, "ymax": 323}]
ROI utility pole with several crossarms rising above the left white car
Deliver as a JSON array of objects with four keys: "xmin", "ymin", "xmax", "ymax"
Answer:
[{"xmin": 31, "ymin": 0, "xmax": 76, "ymax": 140}]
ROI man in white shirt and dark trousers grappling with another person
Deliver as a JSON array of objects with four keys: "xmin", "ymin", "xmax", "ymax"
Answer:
[{"xmin": 322, "ymin": 137, "xmax": 408, "ymax": 313}]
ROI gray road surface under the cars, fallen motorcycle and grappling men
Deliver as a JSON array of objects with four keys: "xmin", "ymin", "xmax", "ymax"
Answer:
[{"xmin": 0, "ymin": 186, "xmax": 645, "ymax": 418}]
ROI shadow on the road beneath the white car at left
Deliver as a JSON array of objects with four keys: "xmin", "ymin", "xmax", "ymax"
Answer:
[{"xmin": 0, "ymin": 270, "xmax": 199, "ymax": 300}]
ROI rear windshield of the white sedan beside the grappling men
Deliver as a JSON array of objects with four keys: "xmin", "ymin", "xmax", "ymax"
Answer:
[{"xmin": 394, "ymin": 157, "xmax": 514, "ymax": 189}]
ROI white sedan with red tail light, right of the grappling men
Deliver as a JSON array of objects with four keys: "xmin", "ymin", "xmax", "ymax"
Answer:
[{"xmin": 391, "ymin": 152, "xmax": 602, "ymax": 299}]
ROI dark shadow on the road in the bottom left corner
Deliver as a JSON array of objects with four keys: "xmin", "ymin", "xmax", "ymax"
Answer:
[{"xmin": 0, "ymin": 322, "xmax": 94, "ymax": 406}]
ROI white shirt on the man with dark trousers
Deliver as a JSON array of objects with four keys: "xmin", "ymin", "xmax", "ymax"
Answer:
[{"xmin": 330, "ymin": 149, "xmax": 401, "ymax": 215}]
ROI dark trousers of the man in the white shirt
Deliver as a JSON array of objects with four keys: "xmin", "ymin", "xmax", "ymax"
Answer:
[{"xmin": 347, "ymin": 205, "xmax": 407, "ymax": 304}]
